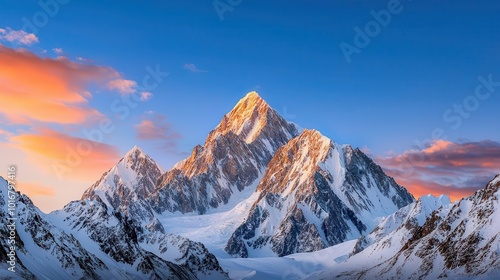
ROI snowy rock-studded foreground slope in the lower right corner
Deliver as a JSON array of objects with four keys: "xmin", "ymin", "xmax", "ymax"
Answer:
[{"xmin": 309, "ymin": 175, "xmax": 500, "ymax": 279}]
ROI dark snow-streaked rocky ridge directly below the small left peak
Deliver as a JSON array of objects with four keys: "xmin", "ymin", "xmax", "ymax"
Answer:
[{"xmin": 57, "ymin": 197, "xmax": 227, "ymax": 279}]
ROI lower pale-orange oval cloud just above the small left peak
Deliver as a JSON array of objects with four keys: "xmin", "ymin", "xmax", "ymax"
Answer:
[{"xmin": 11, "ymin": 129, "xmax": 120, "ymax": 180}]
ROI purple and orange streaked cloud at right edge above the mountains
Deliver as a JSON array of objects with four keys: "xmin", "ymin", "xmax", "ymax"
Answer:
[{"xmin": 376, "ymin": 140, "xmax": 500, "ymax": 199}]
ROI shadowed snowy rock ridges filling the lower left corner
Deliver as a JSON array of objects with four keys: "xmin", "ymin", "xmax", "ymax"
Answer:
[{"xmin": 0, "ymin": 178, "xmax": 218, "ymax": 279}]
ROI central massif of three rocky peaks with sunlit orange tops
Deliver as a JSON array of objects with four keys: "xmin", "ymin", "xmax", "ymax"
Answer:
[{"xmin": 78, "ymin": 92, "xmax": 414, "ymax": 256}]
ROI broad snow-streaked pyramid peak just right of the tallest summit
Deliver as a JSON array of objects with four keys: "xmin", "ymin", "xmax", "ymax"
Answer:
[{"xmin": 226, "ymin": 129, "xmax": 414, "ymax": 257}]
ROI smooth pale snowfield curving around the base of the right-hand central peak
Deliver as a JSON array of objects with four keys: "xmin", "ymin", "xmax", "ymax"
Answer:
[{"xmin": 158, "ymin": 193, "xmax": 356, "ymax": 280}]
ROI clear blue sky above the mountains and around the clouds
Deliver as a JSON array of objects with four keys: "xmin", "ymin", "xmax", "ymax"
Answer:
[{"xmin": 0, "ymin": 0, "xmax": 500, "ymax": 210}]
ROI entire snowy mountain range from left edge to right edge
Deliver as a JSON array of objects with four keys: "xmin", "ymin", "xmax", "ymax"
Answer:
[{"xmin": 0, "ymin": 92, "xmax": 500, "ymax": 279}]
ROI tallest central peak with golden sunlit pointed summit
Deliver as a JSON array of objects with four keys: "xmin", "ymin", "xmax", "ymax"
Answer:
[{"xmin": 150, "ymin": 92, "xmax": 298, "ymax": 214}]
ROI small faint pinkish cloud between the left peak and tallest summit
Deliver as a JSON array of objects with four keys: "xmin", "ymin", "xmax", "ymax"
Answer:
[{"xmin": 135, "ymin": 112, "xmax": 181, "ymax": 151}]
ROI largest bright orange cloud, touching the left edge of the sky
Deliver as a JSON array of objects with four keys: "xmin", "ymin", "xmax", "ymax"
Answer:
[{"xmin": 0, "ymin": 45, "xmax": 119, "ymax": 124}]
